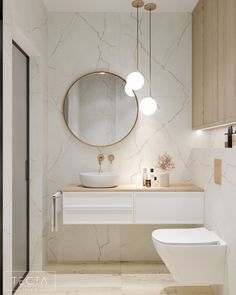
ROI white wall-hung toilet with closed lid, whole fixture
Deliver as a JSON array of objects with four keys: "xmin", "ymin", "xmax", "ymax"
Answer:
[{"xmin": 152, "ymin": 227, "xmax": 226, "ymax": 285}]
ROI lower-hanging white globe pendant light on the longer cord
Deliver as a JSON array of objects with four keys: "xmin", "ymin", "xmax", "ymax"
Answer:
[{"xmin": 139, "ymin": 3, "xmax": 159, "ymax": 116}]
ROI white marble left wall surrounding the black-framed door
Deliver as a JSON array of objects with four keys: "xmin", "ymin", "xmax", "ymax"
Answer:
[{"xmin": 3, "ymin": 0, "xmax": 47, "ymax": 295}]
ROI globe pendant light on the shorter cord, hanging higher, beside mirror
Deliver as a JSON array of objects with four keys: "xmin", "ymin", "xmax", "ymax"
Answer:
[{"xmin": 126, "ymin": 0, "xmax": 144, "ymax": 96}]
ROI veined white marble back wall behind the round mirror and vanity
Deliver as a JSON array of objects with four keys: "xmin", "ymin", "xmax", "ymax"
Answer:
[{"xmin": 48, "ymin": 13, "xmax": 209, "ymax": 261}]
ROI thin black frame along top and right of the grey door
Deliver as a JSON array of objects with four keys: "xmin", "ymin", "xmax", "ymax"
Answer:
[{"xmin": 12, "ymin": 40, "xmax": 30, "ymax": 294}]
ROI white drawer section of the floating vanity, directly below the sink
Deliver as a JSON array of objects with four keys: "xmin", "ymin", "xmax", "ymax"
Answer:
[{"xmin": 63, "ymin": 192, "xmax": 133, "ymax": 224}]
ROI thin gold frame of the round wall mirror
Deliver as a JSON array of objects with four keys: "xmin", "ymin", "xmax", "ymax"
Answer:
[{"xmin": 62, "ymin": 71, "xmax": 139, "ymax": 148}]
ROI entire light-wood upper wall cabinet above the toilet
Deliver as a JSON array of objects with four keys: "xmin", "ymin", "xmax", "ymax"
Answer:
[{"xmin": 193, "ymin": 0, "xmax": 236, "ymax": 129}]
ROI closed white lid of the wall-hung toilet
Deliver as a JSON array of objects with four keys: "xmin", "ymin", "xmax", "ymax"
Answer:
[{"xmin": 152, "ymin": 227, "xmax": 219, "ymax": 245}]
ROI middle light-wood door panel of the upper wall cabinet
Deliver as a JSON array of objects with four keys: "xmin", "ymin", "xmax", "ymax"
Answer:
[{"xmin": 203, "ymin": 0, "xmax": 218, "ymax": 126}]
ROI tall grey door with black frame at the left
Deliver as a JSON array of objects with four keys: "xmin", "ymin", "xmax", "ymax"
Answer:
[{"xmin": 12, "ymin": 42, "xmax": 29, "ymax": 289}]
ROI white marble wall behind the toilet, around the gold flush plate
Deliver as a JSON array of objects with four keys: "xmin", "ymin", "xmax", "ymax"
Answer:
[{"xmin": 192, "ymin": 148, "xmax": 236, "ymax": 295}]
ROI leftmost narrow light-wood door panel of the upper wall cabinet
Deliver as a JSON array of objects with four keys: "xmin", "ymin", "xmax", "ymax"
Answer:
[{"xmin": 192, "ymin": 0, "xmax": 203, "ymax": 129}]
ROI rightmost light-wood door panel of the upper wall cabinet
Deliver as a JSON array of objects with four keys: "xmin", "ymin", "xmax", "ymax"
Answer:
[{"xmin": 218, "ymin": 0, "xmax": 236, "ymax": 123}]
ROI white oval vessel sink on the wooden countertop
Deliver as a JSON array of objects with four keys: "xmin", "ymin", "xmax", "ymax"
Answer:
[{"xmin": 80, "ymin": 172, "xmax": 120, "ymax": 188}]
